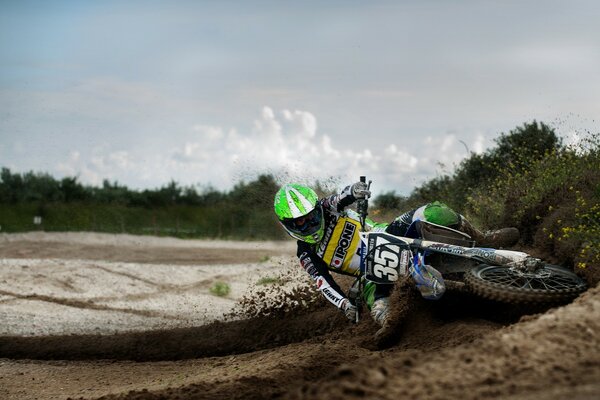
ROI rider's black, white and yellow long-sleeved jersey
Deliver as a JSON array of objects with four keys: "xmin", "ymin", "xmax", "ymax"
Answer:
[{"xmin": 298, "ymin": 186, "xmax": 386, "ymax": 307}]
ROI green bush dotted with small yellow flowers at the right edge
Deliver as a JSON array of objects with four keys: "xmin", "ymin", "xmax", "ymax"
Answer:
[{"xmin": 468, "ymin": 131, "xmax": 600, "ymax": 276}]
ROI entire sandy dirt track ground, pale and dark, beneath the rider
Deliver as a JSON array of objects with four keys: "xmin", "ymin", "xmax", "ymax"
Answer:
[{"xmin": 0, "ymin": 235, "xmax": 600, "ymax": 399}]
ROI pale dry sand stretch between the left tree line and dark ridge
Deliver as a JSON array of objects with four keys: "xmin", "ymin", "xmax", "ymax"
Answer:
[{"xmin": 0, "ymin": 232, "xmax": 292, "ymax": 336}]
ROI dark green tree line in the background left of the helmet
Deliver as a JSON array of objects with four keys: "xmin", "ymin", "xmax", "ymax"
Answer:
[{"xmin": 0, "ymin": 168, "xmax": 284, "ymax": 239}]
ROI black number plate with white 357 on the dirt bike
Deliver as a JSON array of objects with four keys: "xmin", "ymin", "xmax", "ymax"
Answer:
[{"xmin": 365, "ymin": 233, "xmax": 412, "ymax": 283}]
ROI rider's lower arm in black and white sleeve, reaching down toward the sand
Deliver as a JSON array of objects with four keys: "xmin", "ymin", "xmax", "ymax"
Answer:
[{"xmin": 298, "ymin": 242, "xmax": 346, "ymax": 308}]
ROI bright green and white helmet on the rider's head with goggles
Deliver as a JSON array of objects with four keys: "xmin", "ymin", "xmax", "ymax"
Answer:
[{"xmin": 274, "ymin": 183, "xmax": 325, "ymax": 243}]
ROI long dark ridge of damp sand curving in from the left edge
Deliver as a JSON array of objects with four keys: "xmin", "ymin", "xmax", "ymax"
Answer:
[{"xmin": 0, "ymin": 309, "xmax": 343, "ymax": 361}]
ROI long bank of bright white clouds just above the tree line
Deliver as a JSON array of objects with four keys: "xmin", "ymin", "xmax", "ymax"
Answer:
[{"xmin": 50, "ymin": 107, "xmax": 492, "ymax": 193}]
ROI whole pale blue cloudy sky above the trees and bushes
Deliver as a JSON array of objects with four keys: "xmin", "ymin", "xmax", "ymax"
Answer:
[{"xmin": 0, "ymin": 0, "xmax": 600, "ymax": 193}]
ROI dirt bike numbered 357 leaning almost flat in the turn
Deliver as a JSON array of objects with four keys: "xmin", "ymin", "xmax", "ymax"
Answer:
[{"xmin": 351, "ymin": 176, "xmax": 587, "ymax": 318}]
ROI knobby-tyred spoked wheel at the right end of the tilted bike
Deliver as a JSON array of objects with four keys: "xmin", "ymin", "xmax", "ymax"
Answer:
[{"xmin": 465, "ymin": 264, "xmax": 587, "ymax": 303}]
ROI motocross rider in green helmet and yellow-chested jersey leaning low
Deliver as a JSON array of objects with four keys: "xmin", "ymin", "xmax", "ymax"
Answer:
[{"xmin": 274, "ymin": 182, "xmax": 518, "ymax": 325}]
